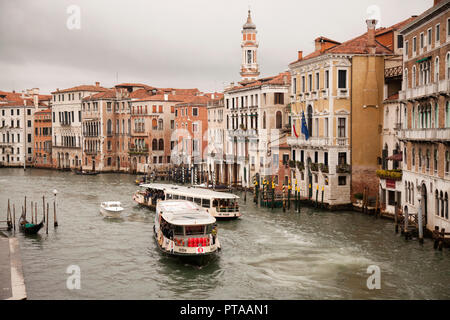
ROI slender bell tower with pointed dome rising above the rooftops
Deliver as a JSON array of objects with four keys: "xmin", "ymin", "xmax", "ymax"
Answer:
[{"xmin": 241, "ymin": 10, "xmax": 259, "ymax": 82}]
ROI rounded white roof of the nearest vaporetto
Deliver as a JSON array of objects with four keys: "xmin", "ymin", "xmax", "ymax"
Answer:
[{"xmin": 156, "ymin": 200, "xmax": 216, "ymax": 226}]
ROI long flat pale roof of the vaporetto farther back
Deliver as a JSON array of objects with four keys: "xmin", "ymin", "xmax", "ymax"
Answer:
[{"xmin": 140, "ymin": 183, "xmax": 239, "ymax": 200}]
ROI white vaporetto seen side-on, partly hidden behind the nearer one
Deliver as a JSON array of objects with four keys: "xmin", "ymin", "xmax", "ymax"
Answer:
[{"xmin": 133, "ymin": 183, "xmax": 241, "ymax": 219}]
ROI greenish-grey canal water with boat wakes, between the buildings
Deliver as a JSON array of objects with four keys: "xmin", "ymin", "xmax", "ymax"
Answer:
[{"xmin": 0, "ymin": 169, "xmax": 450, "ymax": 299}]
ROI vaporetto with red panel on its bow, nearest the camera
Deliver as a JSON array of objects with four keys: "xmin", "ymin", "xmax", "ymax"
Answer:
[{"xmin": 153, "ymin": 200, "xmax": 220, "ymax": 262}]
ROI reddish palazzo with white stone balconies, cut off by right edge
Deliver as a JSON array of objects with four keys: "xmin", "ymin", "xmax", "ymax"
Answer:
[{"xmin": 398, "ymin": 0, "xmax": 450, "ymax": 234}]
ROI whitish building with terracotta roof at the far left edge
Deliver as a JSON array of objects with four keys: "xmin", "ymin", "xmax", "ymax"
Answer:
[{"xmin": 0, "ymin": 88, "xmax": 49, "ymax": 167}]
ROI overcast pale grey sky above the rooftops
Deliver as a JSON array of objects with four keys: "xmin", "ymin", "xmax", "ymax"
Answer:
[{"xmin": 0, "ymin": 0, "xmax": 433, "ymax": 93}]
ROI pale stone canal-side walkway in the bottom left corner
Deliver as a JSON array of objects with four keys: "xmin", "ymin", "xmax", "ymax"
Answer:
[{"xmin": 0, "ymin": 232, "xmax": 27, "ymax": 300}]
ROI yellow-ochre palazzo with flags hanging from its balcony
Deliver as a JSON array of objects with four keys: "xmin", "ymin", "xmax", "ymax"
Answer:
[{"xmin": 288, "ymin": 20, "xmax": 393, "ymax": 208}]
